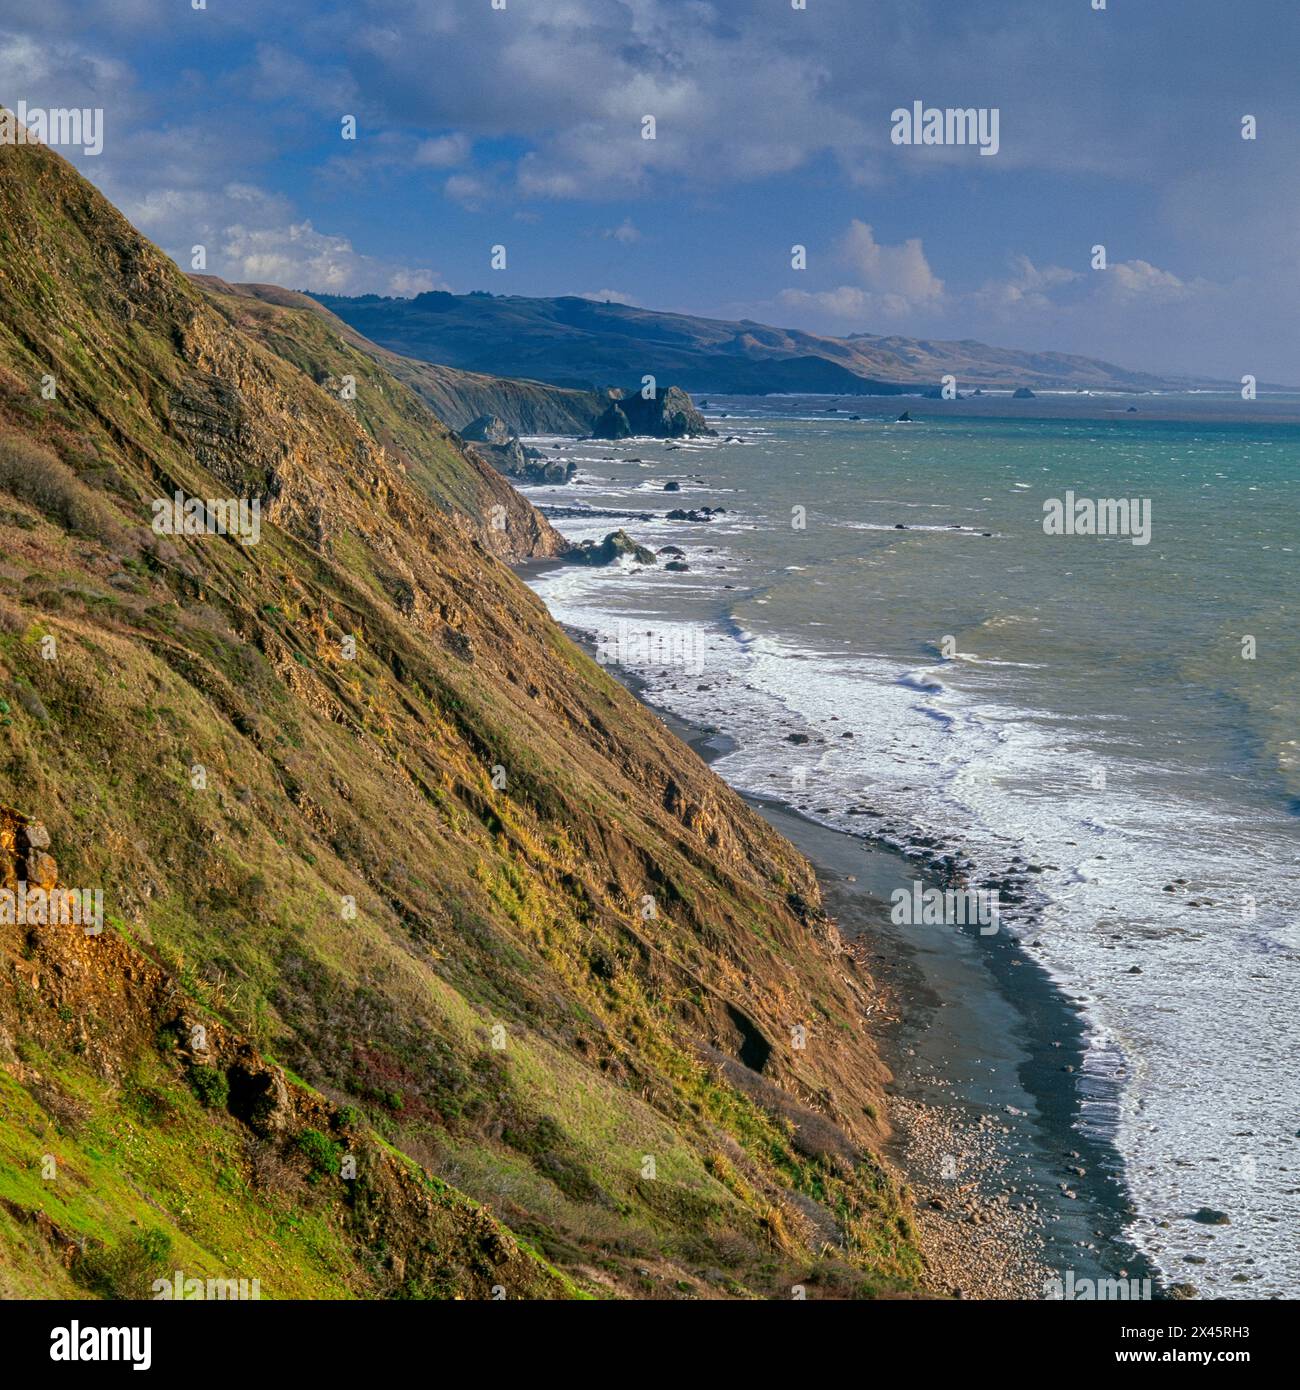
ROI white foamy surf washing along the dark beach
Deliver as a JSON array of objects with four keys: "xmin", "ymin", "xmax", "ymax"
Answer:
[{"xmin": 525, "ymin": 533, "xmax": 1300, "ymax": 1297}]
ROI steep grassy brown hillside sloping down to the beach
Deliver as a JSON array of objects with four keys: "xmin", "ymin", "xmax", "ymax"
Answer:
[{"xmin": 0, "ymin": 135, "xmax": 920, "ymax": 1297}]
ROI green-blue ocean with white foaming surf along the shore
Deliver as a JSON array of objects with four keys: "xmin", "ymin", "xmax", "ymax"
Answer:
[{"xmin": 527, "ymin": 395, "xmax": 1300, "ymax": 1298}]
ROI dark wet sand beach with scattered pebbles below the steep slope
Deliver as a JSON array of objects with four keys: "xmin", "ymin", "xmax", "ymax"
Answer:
[{"xmin": 539, "ymin": 614, "xmax": 1156, "ymax": 1300}]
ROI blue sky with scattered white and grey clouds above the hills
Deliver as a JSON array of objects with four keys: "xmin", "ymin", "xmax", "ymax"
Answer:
[{"xmin": 0, "ymin": 0, "xmax": 1300, "ymax": 385}]
